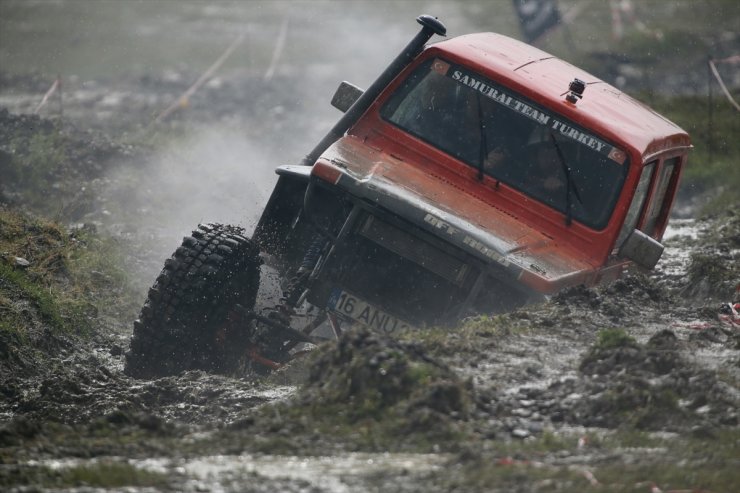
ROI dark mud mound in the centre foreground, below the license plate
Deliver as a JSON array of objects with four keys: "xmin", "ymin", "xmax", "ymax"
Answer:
[{"xmin": 243, "ymin": 328, "xmax": 475, "ymax": 451}]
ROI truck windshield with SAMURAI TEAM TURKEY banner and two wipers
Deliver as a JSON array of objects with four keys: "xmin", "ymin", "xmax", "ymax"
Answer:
[{"xmin": 380, "ymin": 59, "xmax": 628, "ymax": 229}]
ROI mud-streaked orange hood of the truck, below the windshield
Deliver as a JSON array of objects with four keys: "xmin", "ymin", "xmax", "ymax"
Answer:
[{"xmin": 313, "ymin": 136, "xmax": 594, "ymax": 294}]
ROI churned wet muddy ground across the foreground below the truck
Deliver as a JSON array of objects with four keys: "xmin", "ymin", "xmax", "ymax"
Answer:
[{"xmin": 0, "ymin": 193, "xmax": 740, "ymax": 492}]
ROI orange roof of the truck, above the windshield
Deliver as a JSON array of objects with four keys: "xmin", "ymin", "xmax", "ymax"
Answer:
[{"xmin": 428, "ymin": 33, "xmax": 691, "ymax": 156}]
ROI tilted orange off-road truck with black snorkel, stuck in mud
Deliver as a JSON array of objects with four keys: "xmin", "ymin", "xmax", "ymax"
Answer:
[{"xmin": 126, "ymin": 16, "xmax": 691, "ymax": 377}]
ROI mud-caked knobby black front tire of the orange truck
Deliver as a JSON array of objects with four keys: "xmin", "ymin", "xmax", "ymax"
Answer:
[{"xmin": 125, "ymin": 224, "xmax": 261, "ymax": 378}]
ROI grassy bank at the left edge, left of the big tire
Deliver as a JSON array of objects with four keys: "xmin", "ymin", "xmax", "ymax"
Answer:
[{"xmin": 0, "ymin": 208, "xmax": 135, "ymax": 337}]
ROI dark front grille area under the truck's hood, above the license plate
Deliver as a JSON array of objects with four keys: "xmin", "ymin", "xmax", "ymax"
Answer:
[{"xmin": 309, "ymin": 209, "xmax": 479, "ymax": 326}]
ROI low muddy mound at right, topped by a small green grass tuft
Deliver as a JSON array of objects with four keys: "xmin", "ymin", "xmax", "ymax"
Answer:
[{"xmin": 506, "ymin": 329, "xmax": 738, "ymax": 432}]
